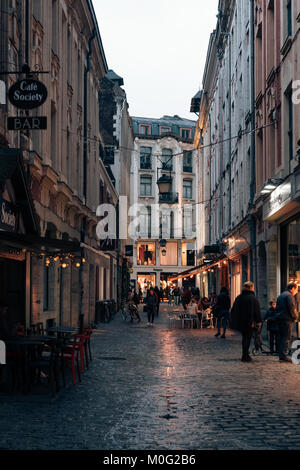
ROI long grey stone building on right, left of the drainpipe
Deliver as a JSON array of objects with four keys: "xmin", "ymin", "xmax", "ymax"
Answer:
[{"xmin": 195, "ymin": 0, "xmax": 252, "ymax": 299}]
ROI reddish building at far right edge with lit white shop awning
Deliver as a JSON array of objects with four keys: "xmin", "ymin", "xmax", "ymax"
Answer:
[{"xmin": 255, "ymin": 0, "xmax": 300, "ymax": 324}]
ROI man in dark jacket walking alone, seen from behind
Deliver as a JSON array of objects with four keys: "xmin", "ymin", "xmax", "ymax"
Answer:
[{"xmin": 231, "ymin": 282, "xmax": 262, "ymax": 362}]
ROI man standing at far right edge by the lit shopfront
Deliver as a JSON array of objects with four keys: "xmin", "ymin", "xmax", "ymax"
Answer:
[{"xmin": 276, "ymin": 282, "xmax": 298, "ymax": 362}]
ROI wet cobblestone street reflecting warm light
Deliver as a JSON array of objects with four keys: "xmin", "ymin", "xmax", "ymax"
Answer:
[{"xmin": 0, "ymin": 306, "xmax": 300, "ymax": 450}]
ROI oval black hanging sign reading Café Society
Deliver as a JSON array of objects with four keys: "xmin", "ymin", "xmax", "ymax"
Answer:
[{"xmin": 8, "ymin": 78, "xmax": 48, "ymax": 109}]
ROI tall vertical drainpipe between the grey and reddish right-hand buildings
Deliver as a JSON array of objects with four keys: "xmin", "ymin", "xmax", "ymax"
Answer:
[{"xmin": 249, "ymin": 0, "xmax": 257, "ymax": 284}]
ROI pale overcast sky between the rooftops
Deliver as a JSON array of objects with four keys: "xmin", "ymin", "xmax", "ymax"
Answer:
[{"xmin": 93, "ymin": 0, "xmax": 218, "ymax": 120}]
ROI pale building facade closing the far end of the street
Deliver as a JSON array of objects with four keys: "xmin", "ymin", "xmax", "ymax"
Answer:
[{"xmin": 130, "ymin": 116, "xmax": 199, "ymax": 290}]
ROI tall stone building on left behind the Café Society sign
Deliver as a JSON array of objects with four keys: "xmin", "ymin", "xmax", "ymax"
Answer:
[{"xmin": 0, "ymin": 0, "xmax": 123, "ymax": 326}]
